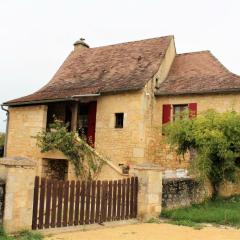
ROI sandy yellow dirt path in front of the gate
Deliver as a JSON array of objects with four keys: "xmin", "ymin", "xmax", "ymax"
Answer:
[{"xmin": 46, "ymin": 223, "xmax": 240, "ymax": 240}]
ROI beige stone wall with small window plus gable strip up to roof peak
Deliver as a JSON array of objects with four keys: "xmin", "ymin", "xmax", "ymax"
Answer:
[{"xmin": 96, "ymin": 39, "xmax": 176, "ymax": 169}]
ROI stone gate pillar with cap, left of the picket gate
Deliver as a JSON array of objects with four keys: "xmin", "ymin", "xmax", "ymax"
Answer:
[{"xmin": 0, "ymin": 157, "xmax": 36, "ymax": 233}]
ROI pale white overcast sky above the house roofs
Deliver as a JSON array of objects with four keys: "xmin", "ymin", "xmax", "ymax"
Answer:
[{"xmin": 0, "ymin": 0, "xmax": 240, "ymax": 131}]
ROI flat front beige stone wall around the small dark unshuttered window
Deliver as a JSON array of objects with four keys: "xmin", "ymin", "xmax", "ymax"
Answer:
[{"xmin": 95, "ymin": 91, "xmax": 147, "ymax": 165}]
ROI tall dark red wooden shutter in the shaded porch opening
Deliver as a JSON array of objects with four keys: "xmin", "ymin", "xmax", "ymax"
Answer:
[{"xmin": 87, "ymin": 102, "xmax": 97, "ymax": 147}]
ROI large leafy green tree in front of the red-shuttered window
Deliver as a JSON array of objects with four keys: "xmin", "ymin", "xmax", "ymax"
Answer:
[{"xmin": 164, "ymin": 110, "xmax": 240, "ymax": 197}]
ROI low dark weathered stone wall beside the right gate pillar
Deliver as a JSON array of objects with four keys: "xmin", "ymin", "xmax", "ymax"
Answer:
[{"xmin": 162, "ymin": 177, "xmax": 206, "ymax": 209}]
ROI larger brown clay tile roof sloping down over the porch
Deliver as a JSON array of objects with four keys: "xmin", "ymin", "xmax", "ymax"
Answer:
[{"xmin": 5, "ymin": 36, "xmax": 172, "ymax": 105}]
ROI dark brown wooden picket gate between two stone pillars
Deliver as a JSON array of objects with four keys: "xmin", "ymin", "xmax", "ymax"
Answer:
[{"xmin": 32, "ymin": 176, "xmax": 138, "ymax": 230}]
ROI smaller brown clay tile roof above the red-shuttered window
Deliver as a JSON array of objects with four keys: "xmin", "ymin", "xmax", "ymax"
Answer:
[{"xmin": 156, "ymin": 51, "xmax": 240, "ymax": 95}]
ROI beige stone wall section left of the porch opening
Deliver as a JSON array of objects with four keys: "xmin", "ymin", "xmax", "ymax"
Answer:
[{"xmin": 7, "ymin": 105, "xmax": 47, "ymax": 173}]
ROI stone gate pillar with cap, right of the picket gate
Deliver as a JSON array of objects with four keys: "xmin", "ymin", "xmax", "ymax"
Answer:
[{"xmin": 132, "ymin": 164, "xmax": 162, "ymax": 221}]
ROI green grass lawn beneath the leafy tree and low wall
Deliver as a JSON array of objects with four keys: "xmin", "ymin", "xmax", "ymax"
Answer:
[{"xmin": 161, "ymin": 196, "xmax": 240, "ymax": 227}]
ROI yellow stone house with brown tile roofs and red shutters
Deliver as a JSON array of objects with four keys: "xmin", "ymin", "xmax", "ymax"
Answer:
[{"xmin": 3, "ymin": 36, "xmax": 240, "ymax": 178}]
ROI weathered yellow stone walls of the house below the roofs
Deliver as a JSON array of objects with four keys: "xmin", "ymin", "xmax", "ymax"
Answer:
[{"xmin": 7, "ymin": 87, "xmax": 240, "ymax": 179}]
